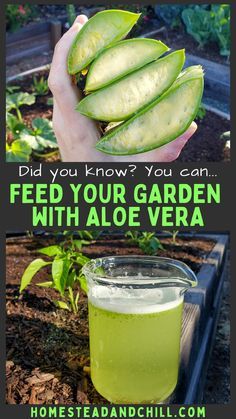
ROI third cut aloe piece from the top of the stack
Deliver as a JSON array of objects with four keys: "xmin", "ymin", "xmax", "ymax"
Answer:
[{"xmin": 76, "ymin": 50, "xmax": 185, "ymax": 122}]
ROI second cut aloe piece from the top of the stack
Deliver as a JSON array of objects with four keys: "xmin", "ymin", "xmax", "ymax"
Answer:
[{"xmin": 85, "ymin": 38, "xmax": 169, "ymax": 92}]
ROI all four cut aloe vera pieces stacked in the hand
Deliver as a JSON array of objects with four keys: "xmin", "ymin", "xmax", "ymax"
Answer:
[{"xmin": 68, "ymin": 10, "xmax": 204, "ymax": 155}]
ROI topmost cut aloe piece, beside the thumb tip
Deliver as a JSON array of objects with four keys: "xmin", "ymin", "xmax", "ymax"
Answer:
[{"xmin": 67, "ymin": 10, "xmax": 140, "ymax": 74}]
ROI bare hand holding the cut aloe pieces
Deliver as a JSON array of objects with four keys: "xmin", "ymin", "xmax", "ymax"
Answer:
[{"xmin": 48, "ymin": 15, "xmax": 197, "ymax": 162}]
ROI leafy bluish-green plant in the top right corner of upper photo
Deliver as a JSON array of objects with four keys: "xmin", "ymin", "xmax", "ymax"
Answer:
[{"xmin": 182, "ymin": 4, "xmax": 230, "ymax": 57}]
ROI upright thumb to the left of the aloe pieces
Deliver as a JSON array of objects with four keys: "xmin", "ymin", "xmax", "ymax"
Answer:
[{"xmin": 48, "ymin": 15, "xmax": 88, "ymax": 110}]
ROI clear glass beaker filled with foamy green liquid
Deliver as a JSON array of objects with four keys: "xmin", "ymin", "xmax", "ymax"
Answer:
[{"xmin": 83, "ymin": 256, "xmax": 197, "ymax": 404}]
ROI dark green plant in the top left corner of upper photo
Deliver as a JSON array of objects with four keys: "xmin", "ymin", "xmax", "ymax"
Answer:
[{"xmin": 6, "ymin": 3, "xmax": 34, "ymax": 32}]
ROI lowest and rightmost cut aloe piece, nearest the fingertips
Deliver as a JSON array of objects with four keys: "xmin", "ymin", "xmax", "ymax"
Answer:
[{"xmin": 96, "ymin": 66, "xmax": 204, "ymax": 155}]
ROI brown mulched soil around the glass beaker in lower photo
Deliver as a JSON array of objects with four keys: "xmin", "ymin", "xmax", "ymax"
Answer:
[{"xmin": 6, "ymin": 235, "xmax": 229, "ymax": 404}]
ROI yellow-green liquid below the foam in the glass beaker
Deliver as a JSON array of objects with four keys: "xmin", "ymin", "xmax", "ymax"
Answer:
[{"xmin": 89, "ymin": 300, "xmax": 183, "ymax": 403}]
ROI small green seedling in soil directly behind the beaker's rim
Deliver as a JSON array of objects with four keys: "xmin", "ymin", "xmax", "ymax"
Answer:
[{"xmin": 125, "ymin": 231, "xmax": 163, "ymax": 255}]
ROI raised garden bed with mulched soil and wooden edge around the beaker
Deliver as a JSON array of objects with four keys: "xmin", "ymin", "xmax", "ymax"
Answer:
[{"xmin": 6, "ymin": 234, "xmax": 227, "ymax": 404}]
